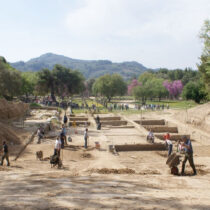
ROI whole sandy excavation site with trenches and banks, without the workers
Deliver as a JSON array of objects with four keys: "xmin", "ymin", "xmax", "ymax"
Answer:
[{"xmin": 0, "ymin": 99, "xmax": 210, "ymax": 209}]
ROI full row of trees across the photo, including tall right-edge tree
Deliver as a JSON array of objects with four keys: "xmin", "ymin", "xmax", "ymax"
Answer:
[{"xmin": 0, "ymin": 20, "xmax": 210, "ymax": 103}]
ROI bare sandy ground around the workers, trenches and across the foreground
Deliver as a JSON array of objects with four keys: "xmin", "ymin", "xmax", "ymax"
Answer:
[{"xmin": 0, "ymin": 107, "xmax": 210, "ymax": 209}]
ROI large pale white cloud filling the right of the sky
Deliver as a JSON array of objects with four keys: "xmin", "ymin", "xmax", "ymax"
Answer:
[{"xmin": 66, "ymin": 0, "xmax": 210, "ymax": 68}]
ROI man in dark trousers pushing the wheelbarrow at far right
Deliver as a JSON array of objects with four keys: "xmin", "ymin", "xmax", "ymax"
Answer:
[{"xmin": 181, "ymin": 136, "xmax": 197, "ymax": 175}]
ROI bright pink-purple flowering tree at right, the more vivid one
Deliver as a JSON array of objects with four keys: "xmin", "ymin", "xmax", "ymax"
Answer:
[{"xmin": 163, "ymin": 80, "xmax": 183, "ymax": 98}]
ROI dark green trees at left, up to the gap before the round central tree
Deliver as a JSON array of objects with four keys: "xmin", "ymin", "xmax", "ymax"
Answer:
[{"xmin": 0, "ymin": 57, "xmax": 85, "ymax": 101}]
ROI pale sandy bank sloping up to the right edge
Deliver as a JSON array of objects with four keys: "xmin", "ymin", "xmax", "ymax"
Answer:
[{"xmin": 174, "ymin": 102, "xmax": 210, "ymax": 132}]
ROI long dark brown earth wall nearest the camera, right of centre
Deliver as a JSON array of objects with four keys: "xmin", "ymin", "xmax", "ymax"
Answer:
[{"xmin": 115, "ymin": 144, "xmax": 166, "ymax": 152}]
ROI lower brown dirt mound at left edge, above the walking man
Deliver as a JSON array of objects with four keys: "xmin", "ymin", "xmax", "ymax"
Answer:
[{"xmin": 0, "ymin": 122, "xmax": 20, "ymax": 145}]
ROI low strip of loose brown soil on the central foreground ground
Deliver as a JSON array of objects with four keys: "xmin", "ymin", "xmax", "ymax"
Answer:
[{"xmin": 90, "ymin": 168, "xmax": 136, "ymax": 174}]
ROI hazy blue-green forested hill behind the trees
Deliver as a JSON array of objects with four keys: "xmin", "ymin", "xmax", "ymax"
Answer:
[{"xmin": 10, "ymin": 53, "xmax": 148, "ymax": 79}]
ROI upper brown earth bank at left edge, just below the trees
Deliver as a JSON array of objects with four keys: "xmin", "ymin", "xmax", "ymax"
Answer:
[{"xmin": 0, "ymin": 99, "xmax": 29, "ymax": 120}]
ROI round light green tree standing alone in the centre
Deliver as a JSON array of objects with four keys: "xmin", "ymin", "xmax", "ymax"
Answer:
[{"xmin": 93, "ymin": 74, "xmax": 127, "ymax": 101}]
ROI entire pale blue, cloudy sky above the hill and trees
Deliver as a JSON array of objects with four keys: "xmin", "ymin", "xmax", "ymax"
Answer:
[{"xmin": 0, "ymin": 0, "xmax": 210, "ymax": 68}]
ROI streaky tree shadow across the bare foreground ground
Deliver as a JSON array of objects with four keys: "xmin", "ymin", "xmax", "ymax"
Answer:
[{"xmin": 0, "ymin": 176, "xmax": 187, "ymax": 209}]
